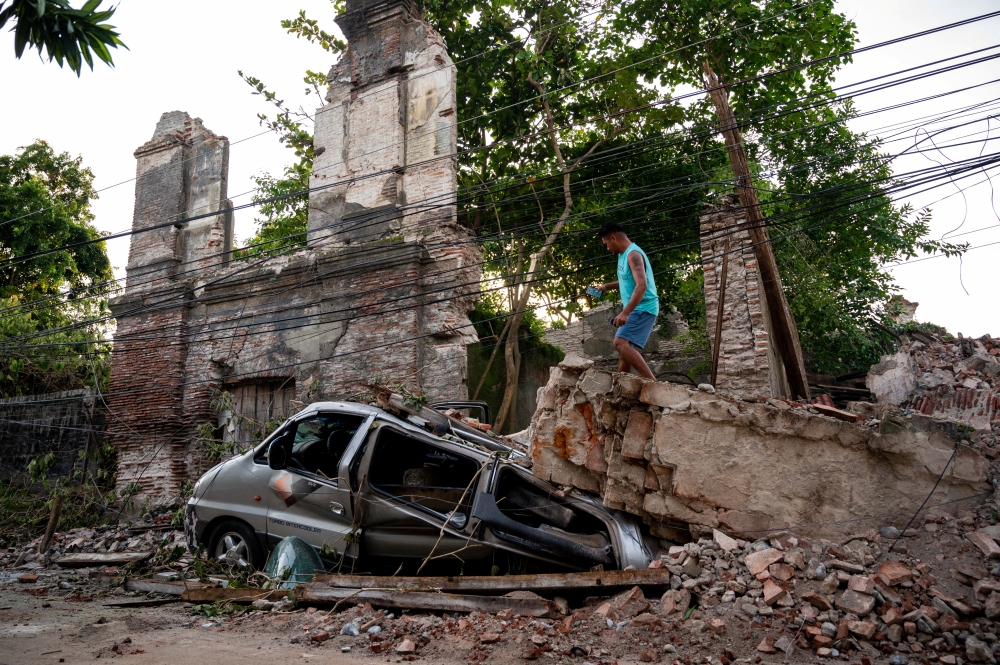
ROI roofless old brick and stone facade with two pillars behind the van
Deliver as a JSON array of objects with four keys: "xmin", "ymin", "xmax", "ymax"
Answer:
[{"xmin": 109, "ymin": 0, "xmax": 481, "ymax": 496}]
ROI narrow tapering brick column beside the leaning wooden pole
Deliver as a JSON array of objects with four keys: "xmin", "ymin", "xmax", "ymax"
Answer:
[{"xmin": 701, "ymin": 194, "xmax": 789, "ymax": 399}]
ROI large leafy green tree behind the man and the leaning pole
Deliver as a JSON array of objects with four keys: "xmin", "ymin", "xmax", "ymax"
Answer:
[{"xmin": 240, "ymin": 0, "xmax": 957, "ymax": 422}]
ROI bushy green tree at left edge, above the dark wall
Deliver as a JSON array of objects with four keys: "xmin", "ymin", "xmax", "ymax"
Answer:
[{"xmin": 0, "ymin": 140, "xmax": 113, "ymax": 397}]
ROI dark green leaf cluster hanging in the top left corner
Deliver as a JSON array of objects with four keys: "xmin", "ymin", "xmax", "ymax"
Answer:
[{"xmin": 0, "ymin": 0, "xmax": 128, "ymax": 76}]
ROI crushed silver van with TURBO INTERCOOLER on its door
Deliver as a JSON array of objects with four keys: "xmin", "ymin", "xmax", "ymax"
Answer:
[{"xmin": 185, "ymin": 402, "xmax": 656, "ymax": 574}]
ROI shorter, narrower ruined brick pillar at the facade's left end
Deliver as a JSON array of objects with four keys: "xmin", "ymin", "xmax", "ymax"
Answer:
[{"xmin": 108, "ymin": 111, "xmax": 233, "ymax": 494}]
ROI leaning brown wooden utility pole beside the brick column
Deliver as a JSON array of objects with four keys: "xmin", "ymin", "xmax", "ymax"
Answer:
[{"xmin": 702, "ymin": 61, "xmax": 809, "ymax": 398}]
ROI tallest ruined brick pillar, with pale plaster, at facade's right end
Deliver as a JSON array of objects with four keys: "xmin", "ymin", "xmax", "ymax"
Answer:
[{"xmin": 309, "ymin": 0, "xmax": 482, "ymax": 399}]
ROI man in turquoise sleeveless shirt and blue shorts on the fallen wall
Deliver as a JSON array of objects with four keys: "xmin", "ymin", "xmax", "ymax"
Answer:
[{"xmin": 597, "ymin": 222, "xmax": 660, "ymax": 380}]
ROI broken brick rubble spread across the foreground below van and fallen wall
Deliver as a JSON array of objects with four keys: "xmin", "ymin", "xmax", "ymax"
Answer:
[{"xmin": 166, "ymin": 507, "xmax": 1000, "ymax": 665}]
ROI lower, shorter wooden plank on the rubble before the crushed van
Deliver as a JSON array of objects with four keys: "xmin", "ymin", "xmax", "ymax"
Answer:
[{"xmin": 295, "ymin": 583, "xmax": 559, "ymax": 617}]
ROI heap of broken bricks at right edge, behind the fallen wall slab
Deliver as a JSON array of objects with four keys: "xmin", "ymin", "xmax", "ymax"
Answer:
[{"xmin": 867, "ymin": 332, "xmax": 1000, "ymax": 442}]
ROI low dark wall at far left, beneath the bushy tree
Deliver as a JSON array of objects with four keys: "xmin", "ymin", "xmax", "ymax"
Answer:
[{"xmin": 0, "ymin": 390, "xmax": 105, "ymax": 481}]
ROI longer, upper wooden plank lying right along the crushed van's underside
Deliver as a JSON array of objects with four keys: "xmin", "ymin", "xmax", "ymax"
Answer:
[{"xmin": 312, "ymin": 568, "xmax": 670, "ymax": 595}]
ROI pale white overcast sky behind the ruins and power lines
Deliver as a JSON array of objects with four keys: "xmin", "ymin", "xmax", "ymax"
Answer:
[{"xmin": 0, "ymin": 0, "xmax": 1000, "ymax": 336}]
